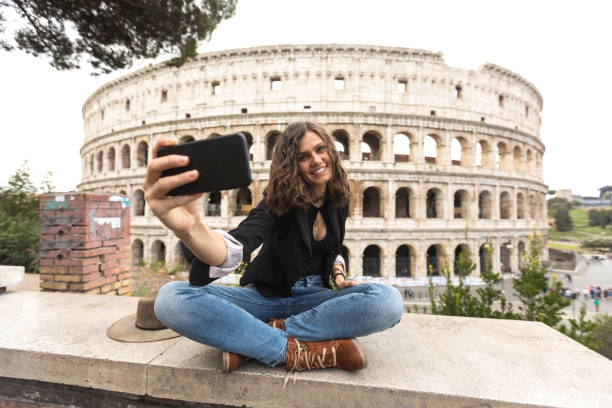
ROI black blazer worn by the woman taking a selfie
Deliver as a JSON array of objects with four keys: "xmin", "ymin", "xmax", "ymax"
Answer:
[{"xmin": 181, "ymin": 200, "xmax": 348, "ymax": 297}]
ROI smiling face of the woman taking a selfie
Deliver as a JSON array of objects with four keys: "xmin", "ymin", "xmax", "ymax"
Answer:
[{"xmin": 296, "ymin": 131, "xmax": 332, "ymax": 196}]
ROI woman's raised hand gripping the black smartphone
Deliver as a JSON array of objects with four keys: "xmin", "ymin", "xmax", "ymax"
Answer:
[{"xmin": 142, "ymin": 138, "xmax": 203, "ymax": 237}]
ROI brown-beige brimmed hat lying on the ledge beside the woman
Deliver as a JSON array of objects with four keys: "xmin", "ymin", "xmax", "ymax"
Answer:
[{"xmin": 106, "ymin": 291, "xmax": 180, "ymax": 343}]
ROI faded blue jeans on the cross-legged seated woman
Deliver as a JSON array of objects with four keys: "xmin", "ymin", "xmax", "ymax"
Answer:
[{"xmin": 155, "ymin": 275, "xmax": 404, "ymax": 366}]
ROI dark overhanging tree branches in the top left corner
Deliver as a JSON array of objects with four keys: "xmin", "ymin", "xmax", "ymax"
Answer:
[{"xmin": 0, "ymin": 0, "xmax": 237, "ymax": 74}]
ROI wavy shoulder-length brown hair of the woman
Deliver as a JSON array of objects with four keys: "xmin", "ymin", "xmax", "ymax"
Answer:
[{"xmin": 266, "ymin": 122, "xmax": 350, "ymax": 216}]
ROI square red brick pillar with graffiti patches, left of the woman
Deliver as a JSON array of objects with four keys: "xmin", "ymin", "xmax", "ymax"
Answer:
[{"xmin": 40, "ymin": 193, "xmax": 130, "ymax": 295}]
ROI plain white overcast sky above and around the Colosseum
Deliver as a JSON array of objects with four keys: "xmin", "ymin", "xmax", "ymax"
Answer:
[{"xmin": 0, "ymin": 0, "xmax": 612, "ymax": 195}]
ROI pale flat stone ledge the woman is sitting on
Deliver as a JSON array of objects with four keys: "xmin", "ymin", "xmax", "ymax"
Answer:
[{"xmin": 0, "ymin": 291, "xmax": 612, "ymax": 408}]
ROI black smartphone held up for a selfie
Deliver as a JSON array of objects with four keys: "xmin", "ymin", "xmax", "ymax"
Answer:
[{"xmin": 157, "ymin": 133, "xmax": 252, "ymax": 196}]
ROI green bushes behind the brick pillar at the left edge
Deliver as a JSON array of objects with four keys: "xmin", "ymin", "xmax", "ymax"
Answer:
[{"xmin": 0, "ymin": 162, "xmax": 53, "ymax": 273}]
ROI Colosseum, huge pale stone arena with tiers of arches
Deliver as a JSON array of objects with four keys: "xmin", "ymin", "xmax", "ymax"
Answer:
[{"xmin": 78, "ymin": 44, "xmax": 547, "ymax": 278}]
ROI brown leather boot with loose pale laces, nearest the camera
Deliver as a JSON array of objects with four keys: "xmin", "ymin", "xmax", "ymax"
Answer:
[{"xmin": 286, "ymin": 336, "xmax": 368, "ymax": 371}]
